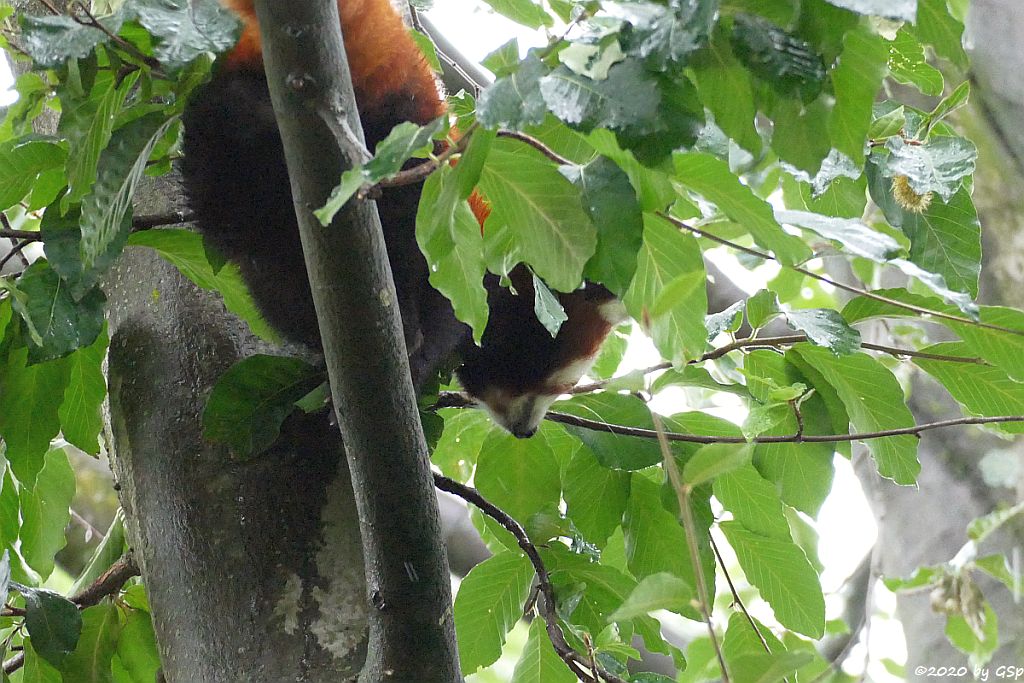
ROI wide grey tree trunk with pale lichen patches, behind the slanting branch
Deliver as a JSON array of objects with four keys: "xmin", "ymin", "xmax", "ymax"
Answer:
[{"xmin": 104, "ymin": 174, "xmax": 368, "ymax": 683}]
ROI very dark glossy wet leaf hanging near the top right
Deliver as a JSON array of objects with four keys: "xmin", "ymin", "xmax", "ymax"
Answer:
[{"xmin": 732, "ymin": 14, "xmax": 825, "ymax": 102}]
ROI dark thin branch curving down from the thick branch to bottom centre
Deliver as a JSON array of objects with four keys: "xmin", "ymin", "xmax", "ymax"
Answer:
[{"xmin": 434, "ymin": 472, "xmax": 626, "ymax": 683}]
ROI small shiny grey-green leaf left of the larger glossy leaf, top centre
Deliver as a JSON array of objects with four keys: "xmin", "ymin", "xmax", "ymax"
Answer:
[{"xmin": 476, "ymin": 54, "xmax": 548, "ymax": 130}]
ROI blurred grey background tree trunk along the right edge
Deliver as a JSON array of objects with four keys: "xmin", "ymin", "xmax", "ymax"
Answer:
[{"xmin": 858, "ymin": 0, "xmax": 1024, "ymax": 680}]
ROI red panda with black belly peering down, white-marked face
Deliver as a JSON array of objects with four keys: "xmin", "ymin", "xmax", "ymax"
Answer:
[{"xmin": 181, "ymin": 0, "xmax": 623, "ymax": 437}]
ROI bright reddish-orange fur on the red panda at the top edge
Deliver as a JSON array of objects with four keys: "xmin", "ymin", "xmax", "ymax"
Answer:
[{"xmin": 221, "ymin": 0, "xmax": 445, "ymax": 123}]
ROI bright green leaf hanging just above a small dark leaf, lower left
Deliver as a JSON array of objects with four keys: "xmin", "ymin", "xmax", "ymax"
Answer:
[{"xmin": 20, "ymin": 449, "xmax": 75, "ymax": 580}]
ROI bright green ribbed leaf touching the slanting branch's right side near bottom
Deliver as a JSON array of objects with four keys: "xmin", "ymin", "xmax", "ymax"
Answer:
[{"xmin": 454, "ymin": 552, "xmax": 534, "ymax": 675}]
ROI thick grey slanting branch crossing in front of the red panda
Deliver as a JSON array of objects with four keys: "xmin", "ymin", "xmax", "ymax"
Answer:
[{"xmin": 249, "ymin": 0, "xmax": 461, "ymax": 683}]
